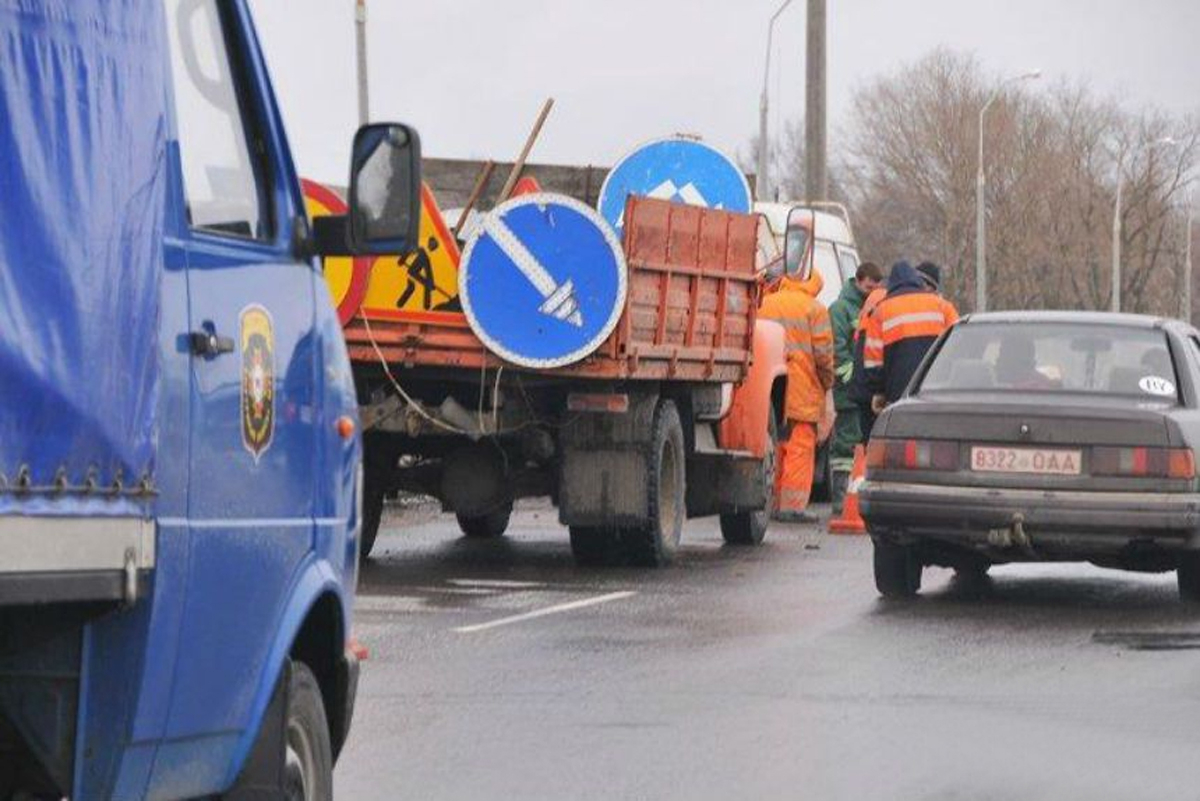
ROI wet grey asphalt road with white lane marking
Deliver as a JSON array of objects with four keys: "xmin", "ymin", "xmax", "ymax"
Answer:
[{"xmin": 335, "ymin": 507, "xmax": 1200, "ymax": 801}]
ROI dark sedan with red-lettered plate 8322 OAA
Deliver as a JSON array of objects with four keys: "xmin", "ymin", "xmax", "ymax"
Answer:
[{"xmin": 859, "ymin": 312, "xmax": 1200, "ymax": 601}]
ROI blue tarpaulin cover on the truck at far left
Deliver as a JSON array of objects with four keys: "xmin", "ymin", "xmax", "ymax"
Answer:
[{"xmin": 0, "ymin": 0, "xmax": 168, "ymax": 514}]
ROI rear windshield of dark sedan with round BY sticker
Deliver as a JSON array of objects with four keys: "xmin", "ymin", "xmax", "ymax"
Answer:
[{"xmin": 920, "ymin": 320, "xmax": 1178, "ymax": 403}]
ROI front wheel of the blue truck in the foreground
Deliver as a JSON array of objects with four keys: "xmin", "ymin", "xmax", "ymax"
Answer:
[{"xmin": 283, "ymin": 662, "xmax": 334, "ymax": 801}]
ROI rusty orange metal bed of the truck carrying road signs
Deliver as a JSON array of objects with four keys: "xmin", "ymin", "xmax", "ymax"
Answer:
[{"xmin": 346, "ymin": 197, "xmax": 758, "ymax": 383}]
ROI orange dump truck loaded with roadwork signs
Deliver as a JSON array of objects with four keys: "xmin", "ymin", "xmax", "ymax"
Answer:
[{"xmin": 314, "ymin": 187, "xmax": 786, "ymax": 566}]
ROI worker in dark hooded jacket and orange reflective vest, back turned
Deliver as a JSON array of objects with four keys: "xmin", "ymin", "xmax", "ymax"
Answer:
[{"xmin": 863, "ymin": 261, "xmax": 959, "ymax": 414}]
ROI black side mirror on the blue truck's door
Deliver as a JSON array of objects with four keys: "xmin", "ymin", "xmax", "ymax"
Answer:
[{"xmin": 347, "ymin": 122, "xmax": 421, "ymax": 255}]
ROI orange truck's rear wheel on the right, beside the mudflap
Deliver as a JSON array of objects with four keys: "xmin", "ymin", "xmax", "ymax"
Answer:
[{"xmin": 622, "ymin": 401, "xmax": 688, "ymax": 567}]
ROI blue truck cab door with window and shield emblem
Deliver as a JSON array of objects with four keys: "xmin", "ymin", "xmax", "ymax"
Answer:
[{"xmin": 151, "ymin": 0, "xmax": 319, "ymax": 796}]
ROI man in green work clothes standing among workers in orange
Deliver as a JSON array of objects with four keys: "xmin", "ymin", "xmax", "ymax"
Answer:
[{"xmin": 829, "ymin": 261, "xmax": 883, "ymax": 514}]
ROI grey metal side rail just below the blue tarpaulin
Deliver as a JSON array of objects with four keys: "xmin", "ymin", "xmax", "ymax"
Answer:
[{"xmin": 0, "ymin": 516, "xmax": 155, "ymax": 607}]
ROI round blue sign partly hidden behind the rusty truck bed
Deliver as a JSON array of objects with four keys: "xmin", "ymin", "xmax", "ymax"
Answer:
[{"xmin": 598, "ymin": 137, "xmax": 752, "ymax": 233}]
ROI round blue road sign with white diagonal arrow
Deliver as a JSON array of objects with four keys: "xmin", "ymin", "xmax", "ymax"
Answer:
[{"xmin": 458, "ymin": 193, "xmax": 626, "ymax": 368}]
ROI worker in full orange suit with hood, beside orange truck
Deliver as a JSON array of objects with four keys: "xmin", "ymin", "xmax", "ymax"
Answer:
[{"xmin": 758, "ymin": 270, "xmax": 834, "ymax": 523}]
